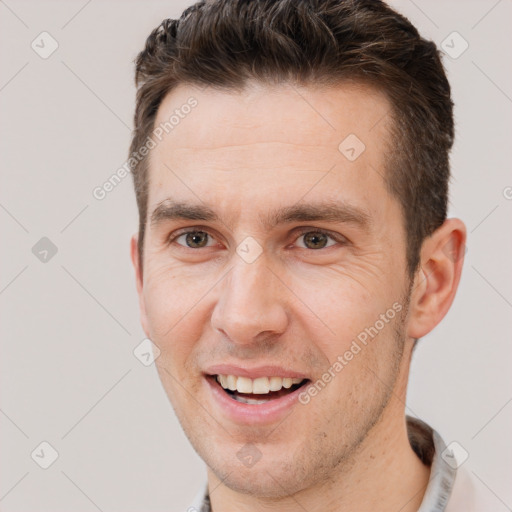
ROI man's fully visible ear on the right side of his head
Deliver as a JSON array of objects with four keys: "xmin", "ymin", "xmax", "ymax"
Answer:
[{"xmin": 407, "ymin": 219, "xmax": 466, "ymax": 339}]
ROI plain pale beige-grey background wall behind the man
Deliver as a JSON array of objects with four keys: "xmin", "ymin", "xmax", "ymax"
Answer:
[{"xmin": 0, "ymin": 0, "xmax": 512, "ymax": 512}]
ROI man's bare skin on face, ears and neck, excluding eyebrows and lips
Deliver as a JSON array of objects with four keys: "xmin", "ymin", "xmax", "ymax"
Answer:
[{"xmin": 131, "ymin": 83, "xmax": 466, "ymax": 512}]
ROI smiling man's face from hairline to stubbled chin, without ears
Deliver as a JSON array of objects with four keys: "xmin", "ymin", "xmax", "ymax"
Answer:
[{"xmin": 135, "ymin": 84, "xmax": 409, "ymax": 496}]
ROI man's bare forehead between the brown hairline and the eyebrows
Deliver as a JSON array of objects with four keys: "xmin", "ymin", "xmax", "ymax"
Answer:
[{"xmin": 148, "ymin": 83, "xmax": 391, "ymax": 222}]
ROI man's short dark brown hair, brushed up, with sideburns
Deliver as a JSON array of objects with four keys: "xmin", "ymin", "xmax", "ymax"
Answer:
[{"xmin": 130, "ymin": 0, "xmax": 454, "ymax": 276}]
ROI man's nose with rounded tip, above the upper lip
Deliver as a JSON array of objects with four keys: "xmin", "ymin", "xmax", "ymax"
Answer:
[{"xmin": 211, "ymin": 257, "xmax": 288, "ymax": 346}]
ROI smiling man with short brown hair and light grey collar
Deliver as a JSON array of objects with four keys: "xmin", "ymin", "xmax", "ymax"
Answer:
[{"xmin": 130, "ymin": 0, "xmax": 483, "ymax": 512}]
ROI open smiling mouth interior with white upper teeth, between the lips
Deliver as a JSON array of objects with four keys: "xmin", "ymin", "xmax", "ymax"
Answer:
[{"xmin": 207, "ymin": 374, "xmax": 310, "ymax": 406}]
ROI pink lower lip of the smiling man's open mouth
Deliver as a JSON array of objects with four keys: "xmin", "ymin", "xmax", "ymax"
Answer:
[{"xmin": 205, "ymin": 378, "xmax": 307, "ymax": 425}]
